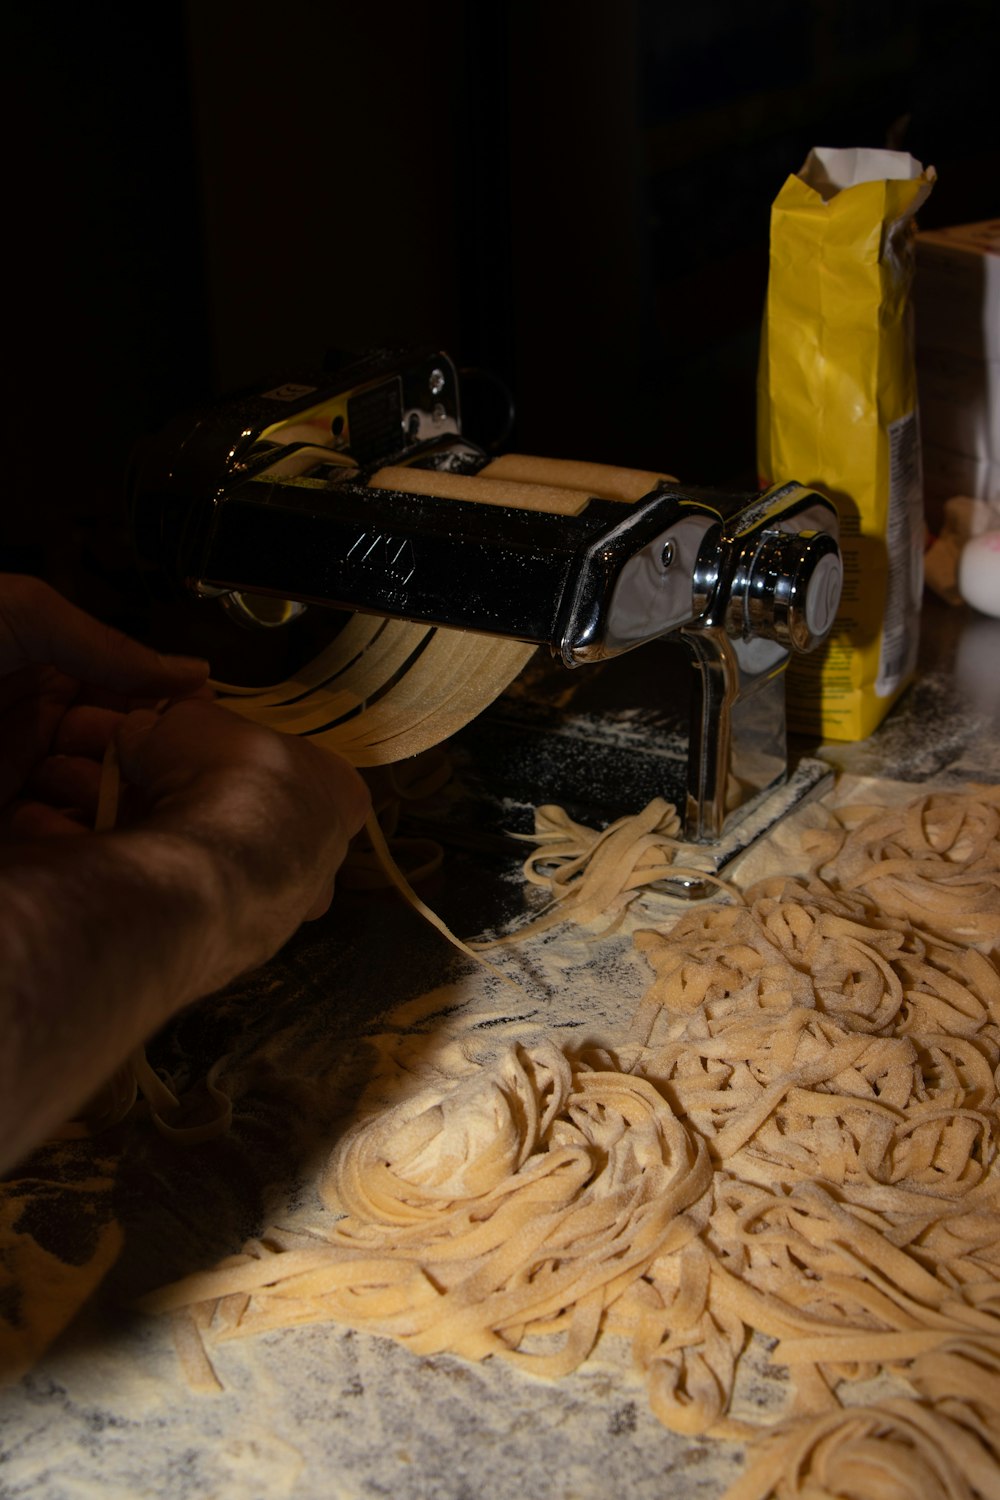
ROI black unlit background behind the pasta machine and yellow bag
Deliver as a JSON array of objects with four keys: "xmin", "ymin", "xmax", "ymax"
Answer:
[{"xmin": 0, "ymin": 0, "xmax": 1000, "ymax": 633}]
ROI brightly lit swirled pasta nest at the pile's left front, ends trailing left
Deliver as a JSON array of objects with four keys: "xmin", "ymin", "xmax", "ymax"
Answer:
[{"xmin": 142, "ymin": 1044, "xmax": 711, "ymax": 1379}]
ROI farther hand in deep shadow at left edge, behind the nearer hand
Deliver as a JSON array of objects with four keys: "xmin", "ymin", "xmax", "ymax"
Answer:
[{"xmin": 0, "ymin": 573, "xmax": 208, "ymax": 837}]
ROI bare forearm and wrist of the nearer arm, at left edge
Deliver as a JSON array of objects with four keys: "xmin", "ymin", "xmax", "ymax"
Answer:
[{"xmin": 0, "ymin": 834, "xmax": 230, "ymax": 1169}]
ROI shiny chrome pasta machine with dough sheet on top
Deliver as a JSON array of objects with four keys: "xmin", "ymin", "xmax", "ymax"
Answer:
[{"xmin": 132, "ymin": 351, "xmax": 843, "ymax": 894}]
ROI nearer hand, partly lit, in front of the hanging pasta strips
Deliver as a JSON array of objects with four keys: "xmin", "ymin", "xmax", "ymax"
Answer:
[{"xmin": 117, "ymin": 699, "xmax": 370, "ymax": 965}]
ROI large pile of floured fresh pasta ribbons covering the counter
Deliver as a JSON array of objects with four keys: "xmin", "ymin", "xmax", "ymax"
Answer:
[{"xmin": 145, "ymin": 788, "xmax": 1000, "ymax": 1500}]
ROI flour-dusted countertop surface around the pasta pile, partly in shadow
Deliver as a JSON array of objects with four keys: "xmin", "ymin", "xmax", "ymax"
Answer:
[{"xmin": 0, "ymin": 756, "xmax": 995, "ymax": 1500}]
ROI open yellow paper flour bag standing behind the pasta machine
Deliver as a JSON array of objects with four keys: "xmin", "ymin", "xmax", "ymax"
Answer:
[{"xmin": 757, "ymin": 147, "xmax": 934, "ymax": 740}]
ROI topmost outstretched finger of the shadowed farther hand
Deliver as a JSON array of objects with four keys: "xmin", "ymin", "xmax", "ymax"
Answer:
[{"xmin": 0, "ymin": 573, "xmax": 208, "ymax": 696}]
